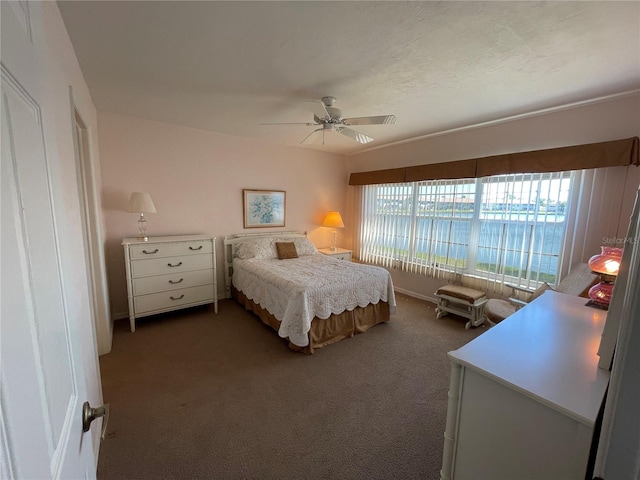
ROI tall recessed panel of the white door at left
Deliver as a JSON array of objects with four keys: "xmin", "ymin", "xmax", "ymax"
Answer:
[{"xmin": 2, "ymin": 66, "xmax": 77, "ymax": 449}]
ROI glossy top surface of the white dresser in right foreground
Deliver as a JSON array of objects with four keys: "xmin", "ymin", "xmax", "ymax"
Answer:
[{"xmin": 449, "ymin": 291, "xmax": 610, "ymax": 425}]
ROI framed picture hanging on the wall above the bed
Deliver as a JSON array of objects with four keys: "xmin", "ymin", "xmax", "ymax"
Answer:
[{"xmin": 242, "ymin": 190, "xmax": 286, "ymax": 228}]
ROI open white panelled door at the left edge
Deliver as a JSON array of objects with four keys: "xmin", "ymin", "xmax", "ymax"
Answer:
[{"xmin": 0, "ymin": 2, "xmax": 101, "ymax": 479}]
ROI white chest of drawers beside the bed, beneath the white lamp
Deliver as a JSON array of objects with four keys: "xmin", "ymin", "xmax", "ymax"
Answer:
[{"xmin": 122, "ymin": 235, "xmax": 218, "ymax": 332}]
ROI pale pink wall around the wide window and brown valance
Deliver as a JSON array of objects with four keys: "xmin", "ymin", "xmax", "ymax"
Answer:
[{"xmin": 347, "ymin": 92, "xmax": 640, "ymax": 299}]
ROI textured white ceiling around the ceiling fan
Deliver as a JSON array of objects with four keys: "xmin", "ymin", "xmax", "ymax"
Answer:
[{"xmin": 58, "ymin": 1, "xmax": 640, "ymax": 154}]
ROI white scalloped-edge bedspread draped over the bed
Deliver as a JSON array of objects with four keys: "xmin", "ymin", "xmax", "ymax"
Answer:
[{"xmin": 233, "ymin": 254, "xmax": 396, "ymax": 347}]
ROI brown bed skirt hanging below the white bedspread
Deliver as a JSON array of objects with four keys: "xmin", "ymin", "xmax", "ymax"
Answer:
[{"xmin": 231, "ymin": 286, "xmax": 391, "ymax": 354}]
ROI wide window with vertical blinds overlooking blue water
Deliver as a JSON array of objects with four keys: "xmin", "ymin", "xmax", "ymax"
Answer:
[{"xmin": 360, "ymin": 172, "xmax": 573, "ymax": 284}]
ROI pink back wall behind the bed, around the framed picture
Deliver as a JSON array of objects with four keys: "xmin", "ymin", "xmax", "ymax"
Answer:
[{"xmin": 98, "ymin": 113, "xmax": 351, "ymax": 318}]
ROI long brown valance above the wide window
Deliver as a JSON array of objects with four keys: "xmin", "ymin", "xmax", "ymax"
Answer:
[{"xmin": 349, "ymin": 137, "xmax": 640, "ymax": 185}]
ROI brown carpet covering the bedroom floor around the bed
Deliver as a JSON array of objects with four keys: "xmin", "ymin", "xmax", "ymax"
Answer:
[{"xmin": 98, "ymin": 295, "xmax": 486, "ymax": 480}]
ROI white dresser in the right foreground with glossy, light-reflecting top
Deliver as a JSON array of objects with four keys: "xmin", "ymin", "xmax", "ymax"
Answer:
[{"xmin": 441, "ymin": 291, "xmax": 609, "ymax": 480}]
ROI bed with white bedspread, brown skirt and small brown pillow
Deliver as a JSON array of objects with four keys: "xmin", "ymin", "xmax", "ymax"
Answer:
[{"xmin": 224, "ymin": 232, "xmax": 396, "ymax": 353}]
